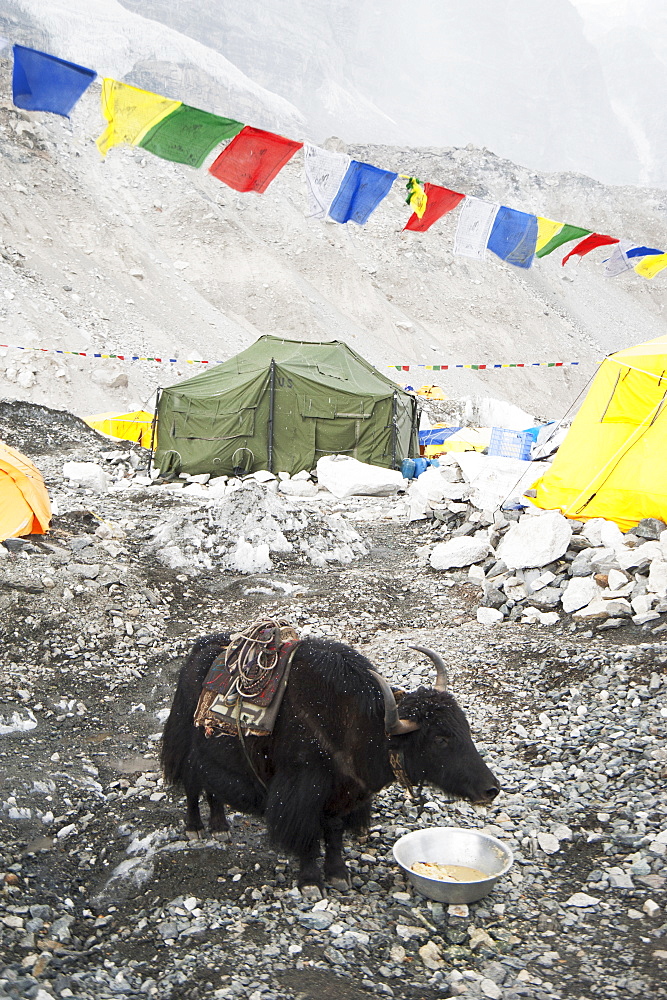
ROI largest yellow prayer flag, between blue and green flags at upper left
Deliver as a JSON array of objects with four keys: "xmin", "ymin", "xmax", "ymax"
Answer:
[{"xmin": 97, "ymin": 79, "xmax": 183, "ymax": 156}]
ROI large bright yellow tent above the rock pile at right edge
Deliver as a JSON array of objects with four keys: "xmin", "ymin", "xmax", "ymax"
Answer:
[{"xmin": 534, "ymin": 336, "xmax": 667, "ymax": 530}]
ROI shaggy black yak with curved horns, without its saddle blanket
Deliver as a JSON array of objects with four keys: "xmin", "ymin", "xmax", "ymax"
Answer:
[{"xmin": 161, "ymin": 634, "xmax": 499, "ymax": 888}]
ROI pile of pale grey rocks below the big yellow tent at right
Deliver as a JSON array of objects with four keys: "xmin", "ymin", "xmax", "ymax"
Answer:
[{"xmin": 413, "ymin": 460, "xmax": 667, "ymax": 630}]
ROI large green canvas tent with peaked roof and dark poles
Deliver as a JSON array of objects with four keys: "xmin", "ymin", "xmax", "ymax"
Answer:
[{"xmin": 154, "ymin": 335, "xmax": 419, "ymax": 475}]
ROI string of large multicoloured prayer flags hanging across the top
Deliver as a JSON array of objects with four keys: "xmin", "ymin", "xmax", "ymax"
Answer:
[{"xmin": 5, "ymin": 45, "xmax": 667, "ymax": 279}]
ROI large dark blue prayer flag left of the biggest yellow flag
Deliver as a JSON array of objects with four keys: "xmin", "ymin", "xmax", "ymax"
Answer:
[{"xmin": 12, "ymin": 45, "xmax": 97, "ymax": 118}]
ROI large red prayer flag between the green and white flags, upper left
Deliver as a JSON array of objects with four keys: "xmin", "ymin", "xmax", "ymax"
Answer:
[{"xmin": 209, "ymin": 125, "xmax": 303, "ymax": 194}]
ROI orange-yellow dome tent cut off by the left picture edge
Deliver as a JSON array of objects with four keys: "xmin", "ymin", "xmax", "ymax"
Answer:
[{"xmin": 0, "ymin": 441, "xmax": 51, "ymax": 541}]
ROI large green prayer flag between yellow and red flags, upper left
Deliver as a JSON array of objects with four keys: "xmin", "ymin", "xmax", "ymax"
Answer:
[{"xmin": 139, "ymin": 104, "xmax": 243, "ymax": 167}]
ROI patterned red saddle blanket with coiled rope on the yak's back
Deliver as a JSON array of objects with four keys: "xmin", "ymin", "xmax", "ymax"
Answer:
[{"xmin": 194, "ymin": 619, "xmax": 299, "ymax": 736}]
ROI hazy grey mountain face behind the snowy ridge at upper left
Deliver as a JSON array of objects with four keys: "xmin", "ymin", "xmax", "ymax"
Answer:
[{"xmin": 111, "ymin": 0, "xmax": 667, "ymax": 185}]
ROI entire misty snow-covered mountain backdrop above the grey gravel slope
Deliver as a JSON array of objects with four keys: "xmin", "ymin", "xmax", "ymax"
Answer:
[{"xmin": 5, "ymin": 0, "xmax": 667, "ymax": 186}]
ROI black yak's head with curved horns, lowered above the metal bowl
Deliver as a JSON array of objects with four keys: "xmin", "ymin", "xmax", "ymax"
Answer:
[{"xmin": 375, "ymin": 646, "xmax": 500, "ymax": 804}]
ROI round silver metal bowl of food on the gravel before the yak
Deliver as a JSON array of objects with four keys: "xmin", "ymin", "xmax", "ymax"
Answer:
[{"xmin": 394, "ymin": 826, "xmax": 514, "ymax": 903}]
